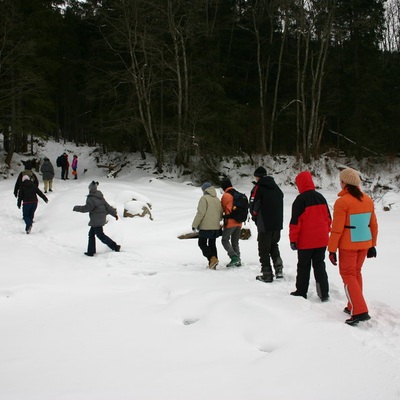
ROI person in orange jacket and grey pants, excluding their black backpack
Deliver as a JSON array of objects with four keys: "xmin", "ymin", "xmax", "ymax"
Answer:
[{"xmin": 221, "ymin": 178, "xmax": 242, "ymax": 267}]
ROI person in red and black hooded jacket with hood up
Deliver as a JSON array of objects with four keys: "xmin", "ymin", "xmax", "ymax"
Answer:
[{"xmin": 289, "ymin": 171, "xmax": 331, "ymax": 301}]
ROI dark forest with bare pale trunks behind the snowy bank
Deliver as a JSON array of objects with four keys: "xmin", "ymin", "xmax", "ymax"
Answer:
[{"xmin": 0, "ymin": 0, "xmax": 400, "ymax": 167}]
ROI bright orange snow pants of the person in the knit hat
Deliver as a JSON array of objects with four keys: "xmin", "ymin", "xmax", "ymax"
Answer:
[{"xmin": 339, "ymin": 249, "xmax": 368, "ymax": 315}]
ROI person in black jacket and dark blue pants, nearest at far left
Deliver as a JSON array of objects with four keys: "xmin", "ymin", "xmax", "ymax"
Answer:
[{"xmin": 17, "ymin": 175, "xmax": 49, "ymax": 234}]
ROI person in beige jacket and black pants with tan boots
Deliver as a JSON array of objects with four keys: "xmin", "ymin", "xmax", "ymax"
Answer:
[{"xmin": 192, "ymin": 182, "xmax": 222, "ymax": 269}]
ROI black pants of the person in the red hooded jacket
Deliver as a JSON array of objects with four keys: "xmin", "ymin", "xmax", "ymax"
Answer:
[{"xmin": 296, "ymin": 247, "xmax": 329, "ymax": 297}]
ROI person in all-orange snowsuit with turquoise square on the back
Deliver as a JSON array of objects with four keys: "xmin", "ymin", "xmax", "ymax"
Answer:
[{"xmin": 328, "ymin": 168, "xmax": 378, "ymax": 325}]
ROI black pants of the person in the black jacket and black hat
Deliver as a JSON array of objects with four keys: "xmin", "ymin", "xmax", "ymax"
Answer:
[{"xmin": 257, "ymin": 231, "xmax": 282, "ymax": 276}]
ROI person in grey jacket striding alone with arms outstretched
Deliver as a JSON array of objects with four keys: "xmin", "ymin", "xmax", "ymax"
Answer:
[{"xmin": 73, "ymin": 181, "xmax": 121, "ymax": 257}]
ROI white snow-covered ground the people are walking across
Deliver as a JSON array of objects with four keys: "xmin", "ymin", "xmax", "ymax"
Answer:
[{"xmin": 0, "ymin": 143, "xmax": 400, "ymax": 400}]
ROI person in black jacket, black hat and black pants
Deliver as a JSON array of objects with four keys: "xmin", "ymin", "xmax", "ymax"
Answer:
[{"xmin": 250, "ymin": 167, "xmax": 283, "ymax": 282}]
